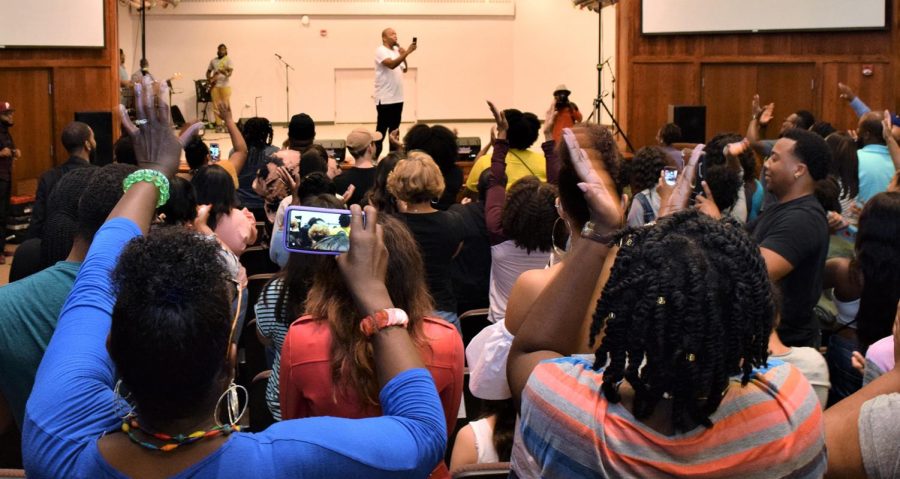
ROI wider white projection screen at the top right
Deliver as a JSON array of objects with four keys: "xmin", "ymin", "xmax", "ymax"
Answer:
[{"xmin": 641, "ymin": 0, "xmax": 887, "ymax": 35}]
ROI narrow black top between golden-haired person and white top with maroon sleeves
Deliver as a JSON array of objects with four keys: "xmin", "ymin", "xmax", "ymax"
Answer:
[{"xmin": 449, "ymin": 201, "xmax": 491, "ymax": 313}]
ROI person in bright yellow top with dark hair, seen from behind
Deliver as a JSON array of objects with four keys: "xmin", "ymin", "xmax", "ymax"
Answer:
[{"xmin": 466, "ymin": 109, "xmax": 554, "ymax": 191}]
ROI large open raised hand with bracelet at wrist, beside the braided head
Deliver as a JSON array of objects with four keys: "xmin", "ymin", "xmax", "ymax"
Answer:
[{"xmin": 563, "ymin": 128, "xmax": 623, "ymax": 233}]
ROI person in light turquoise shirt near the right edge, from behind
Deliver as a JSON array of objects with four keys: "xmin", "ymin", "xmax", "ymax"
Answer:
[{"xmin": 856, "ymin": 112, "xmax": 896, "ymax": 205}]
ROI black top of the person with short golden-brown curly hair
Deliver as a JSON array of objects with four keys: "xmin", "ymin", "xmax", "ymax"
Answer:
[{"xmin": 400, "ymin": 211, "xmax": 463, "ymax": 313}]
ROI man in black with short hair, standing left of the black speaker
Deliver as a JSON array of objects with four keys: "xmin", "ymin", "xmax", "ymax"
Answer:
[{"xmin": 28, "ymin": 121, "xmax": 97, "ymax": 238}]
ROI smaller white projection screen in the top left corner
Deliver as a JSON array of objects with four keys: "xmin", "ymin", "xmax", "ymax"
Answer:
[{"xmin": 0, "ymin": 0, "xmax": 105, "ymax": 48}]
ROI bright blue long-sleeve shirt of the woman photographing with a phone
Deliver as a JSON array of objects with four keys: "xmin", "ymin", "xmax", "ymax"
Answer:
[{"xmin": 22, "ymin": 219, "xmax": 447, "ymax": 478}]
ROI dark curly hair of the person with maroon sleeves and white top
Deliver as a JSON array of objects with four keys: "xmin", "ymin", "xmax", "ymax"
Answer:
[{"xmin": 500, "ymin": 176, "xmax": 559, "ymax": 254}]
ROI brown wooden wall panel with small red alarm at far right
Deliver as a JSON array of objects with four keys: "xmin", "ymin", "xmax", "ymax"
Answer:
[{"xmin": 821, "ymin": 63, "xmax": 894, "ymax": 130}]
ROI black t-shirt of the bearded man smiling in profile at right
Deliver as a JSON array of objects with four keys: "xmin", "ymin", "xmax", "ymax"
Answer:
[{"xmin": 753, "ymin": 195, "xmax": 828, "ymax": 346}]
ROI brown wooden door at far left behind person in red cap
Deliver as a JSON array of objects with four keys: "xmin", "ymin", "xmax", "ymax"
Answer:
[{"xmin": 0, "ymin": 69, "xmax": 54, "ymax": 195}]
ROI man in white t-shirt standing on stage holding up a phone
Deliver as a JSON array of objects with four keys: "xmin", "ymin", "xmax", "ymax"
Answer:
[{"xmin": 375, "ymin": 28, "xmax": 416, "ymax": 158}]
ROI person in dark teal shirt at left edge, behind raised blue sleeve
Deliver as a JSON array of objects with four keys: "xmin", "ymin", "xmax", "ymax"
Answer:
[{"xmin": 0, "ymin": 163, "xmax": 136, "ymax": 436}]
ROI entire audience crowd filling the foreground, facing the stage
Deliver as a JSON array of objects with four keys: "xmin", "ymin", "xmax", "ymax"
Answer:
[{"xmin": 0, "ymin": 70, "xmax": 900, "ymax": 478}]
